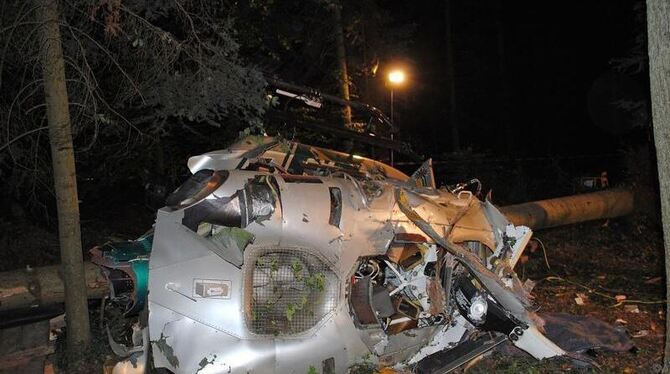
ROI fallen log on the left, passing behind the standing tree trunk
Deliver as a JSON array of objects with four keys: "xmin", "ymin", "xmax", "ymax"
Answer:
[{"xmin": 0, "ymin": 262, "xmax": 109, "ymax": 312}]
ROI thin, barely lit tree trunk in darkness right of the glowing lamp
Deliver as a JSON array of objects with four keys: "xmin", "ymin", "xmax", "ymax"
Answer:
[{"xmin": 444, "ymin": 0, "xmax": 461, "ymax": 152}]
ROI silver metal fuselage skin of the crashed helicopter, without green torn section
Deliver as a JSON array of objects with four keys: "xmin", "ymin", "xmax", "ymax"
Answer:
[{"xmin": 111, "ymin": 137, "xmax": 565, "ymax": 373}]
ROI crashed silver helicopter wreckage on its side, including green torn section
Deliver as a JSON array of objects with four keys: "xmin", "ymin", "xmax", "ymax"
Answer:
[{"xmin": 92, "ymin": 137, "xmax": 632, "ymax": 373}]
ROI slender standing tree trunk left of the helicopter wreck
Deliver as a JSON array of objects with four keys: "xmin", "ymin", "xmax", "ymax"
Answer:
[{"xmin": 35, "ymin": 0, "xmax": 91, "ymax": 350}]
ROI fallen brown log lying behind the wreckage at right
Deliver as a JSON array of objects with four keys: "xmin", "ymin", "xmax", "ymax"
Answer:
[{"xmin": 500, "ymin": 188, "xmax": 635, "ymax": 230}]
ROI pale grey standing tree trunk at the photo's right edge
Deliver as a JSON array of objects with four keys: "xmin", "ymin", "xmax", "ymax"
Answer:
[{"xmin": 647, "ymin": 0, "xmax": 670, "ymax": 373}]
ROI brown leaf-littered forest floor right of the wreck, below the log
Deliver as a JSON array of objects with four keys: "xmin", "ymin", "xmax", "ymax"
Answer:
[{"xmin": 471, "ymin": 218, "xmax": 665, "ymax": 374}]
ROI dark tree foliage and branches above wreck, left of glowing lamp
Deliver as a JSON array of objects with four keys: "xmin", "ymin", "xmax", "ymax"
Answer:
[{"xmin": 0, "ymin": 0, "xmax": 411, "ymax": 219}]
